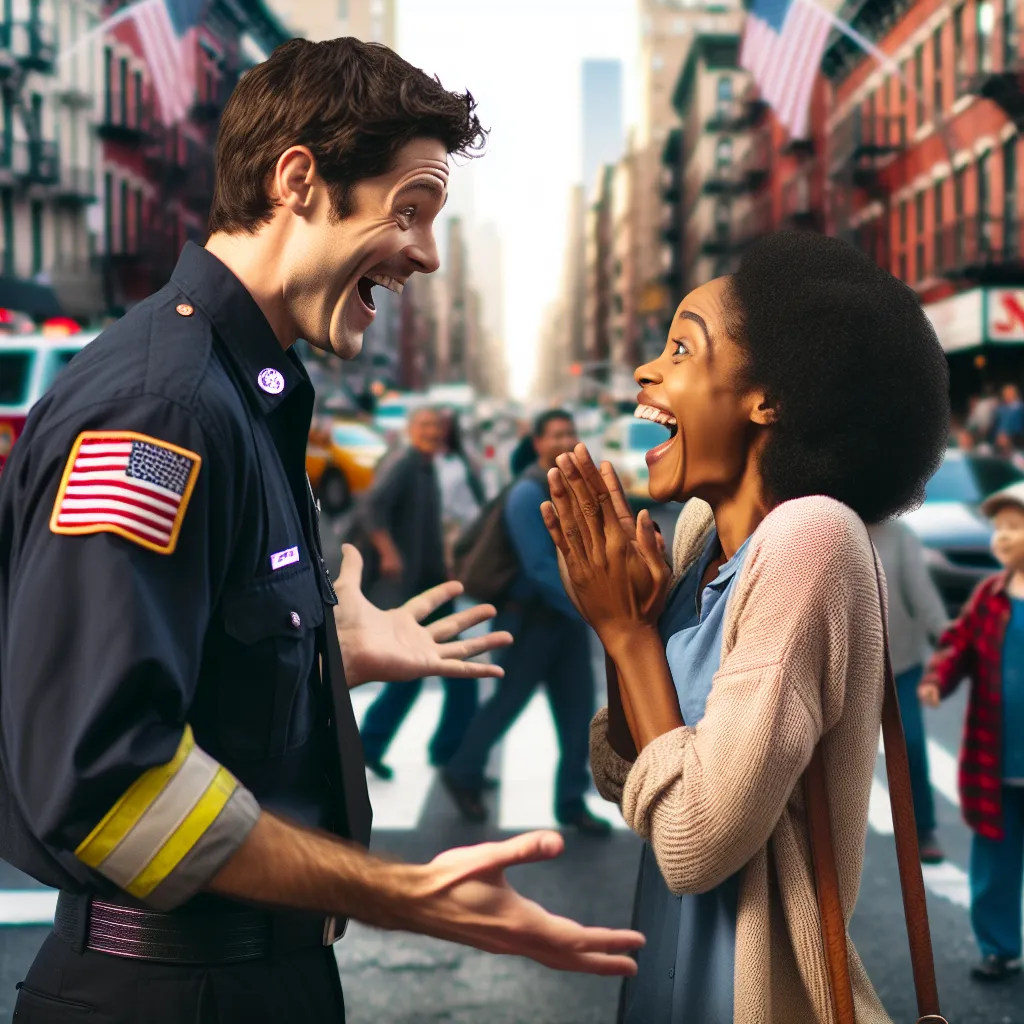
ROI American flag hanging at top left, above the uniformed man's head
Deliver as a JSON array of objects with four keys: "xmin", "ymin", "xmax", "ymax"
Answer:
[{"xmin": 125, "ymin": 0, "xmax": 207, "ymax": 127}]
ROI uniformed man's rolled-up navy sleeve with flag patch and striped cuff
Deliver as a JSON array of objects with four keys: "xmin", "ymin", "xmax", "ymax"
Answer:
[{"xmin": 0, "ymin": 396, "xmax": 260, "ymax": 909}]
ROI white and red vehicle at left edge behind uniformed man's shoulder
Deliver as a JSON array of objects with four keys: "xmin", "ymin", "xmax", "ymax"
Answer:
[{"xmin": 0, "ymin": 331, "xmax": 98, "ymax": 471}]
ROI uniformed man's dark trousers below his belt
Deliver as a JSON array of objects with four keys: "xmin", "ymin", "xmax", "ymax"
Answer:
[{"xmin": 14, "ymin": 933, "xmax": 345, "ymax": 1024}]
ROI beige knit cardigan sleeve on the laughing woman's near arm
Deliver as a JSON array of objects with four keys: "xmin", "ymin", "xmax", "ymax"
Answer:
[{"xmin": 622, "ymin": 498, "xmax": 882, "ymax": 895}]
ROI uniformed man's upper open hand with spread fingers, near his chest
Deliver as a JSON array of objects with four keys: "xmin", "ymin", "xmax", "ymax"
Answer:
[{"xmin": 334, "ymin": 544, "xmax": 512, "ymax": 687}]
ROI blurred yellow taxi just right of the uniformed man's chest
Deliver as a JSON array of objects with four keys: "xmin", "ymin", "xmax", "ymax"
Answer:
[{"xmin": 306, "ymin": 417, "xmax": 387, "ymax": 515}]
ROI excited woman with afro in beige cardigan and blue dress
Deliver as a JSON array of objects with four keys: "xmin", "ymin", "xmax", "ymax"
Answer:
[{"xmin": 544, "ymin": 232, "xmax": 949, "ymax": 1024}]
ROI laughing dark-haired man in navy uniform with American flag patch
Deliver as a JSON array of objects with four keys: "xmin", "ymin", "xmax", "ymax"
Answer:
[{"xmin": 0, "ymin": 39, "xmax": 642, "ymax": 1024}]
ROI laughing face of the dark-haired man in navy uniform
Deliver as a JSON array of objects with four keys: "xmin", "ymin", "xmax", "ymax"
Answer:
[{"xmin": 286, "ymin": 138, "xmax": 449, "ymax": 359}]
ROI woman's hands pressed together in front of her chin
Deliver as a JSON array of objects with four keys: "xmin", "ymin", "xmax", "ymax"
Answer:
[{"xmin": 541, "ymin": 444, "xmax": 672, "ymax": 646}]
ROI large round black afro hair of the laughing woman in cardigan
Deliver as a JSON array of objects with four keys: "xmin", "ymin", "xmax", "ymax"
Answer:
[{"xmin": 728, "ymin": 231, "xmax": 949, "ymax": 522}]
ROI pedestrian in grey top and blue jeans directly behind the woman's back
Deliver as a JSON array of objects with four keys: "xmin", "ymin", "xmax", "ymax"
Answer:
[{"xmin": 868, "ymin": 519, "xmax": 949, "ymax": 864}]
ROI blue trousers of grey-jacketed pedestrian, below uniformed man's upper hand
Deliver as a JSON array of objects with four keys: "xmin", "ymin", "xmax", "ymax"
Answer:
[{"xmin": 359, "ymin": 679, "xmax": 478, "ymax": 765}]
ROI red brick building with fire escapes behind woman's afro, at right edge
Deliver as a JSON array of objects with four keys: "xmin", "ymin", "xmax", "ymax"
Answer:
[{"xmin": 823, "ymin": 0, "xmax": 1024, "ymax": 408}]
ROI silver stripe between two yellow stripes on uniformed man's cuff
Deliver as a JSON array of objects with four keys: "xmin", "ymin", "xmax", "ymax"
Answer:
[{"xmin": 98, "ymin": 746, "xmax": 220, "ymax": 889}]
